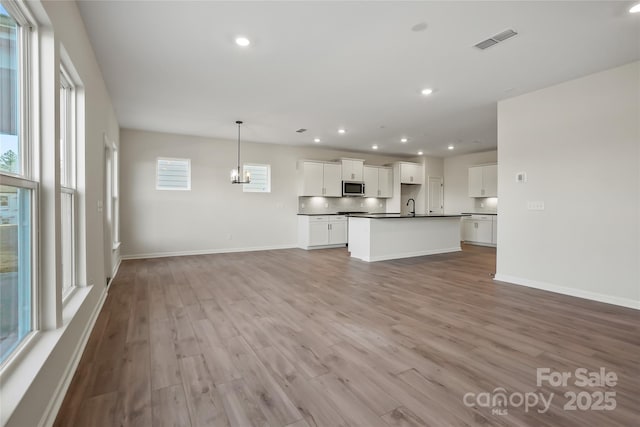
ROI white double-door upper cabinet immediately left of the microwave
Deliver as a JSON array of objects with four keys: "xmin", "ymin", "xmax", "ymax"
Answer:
[{"xmin": 300, "ymin": 161, "xmax": 342, "ymax": 197}]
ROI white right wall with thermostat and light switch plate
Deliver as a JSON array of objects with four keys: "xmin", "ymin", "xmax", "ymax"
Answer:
[{"xmin": 496, "ymin": 62, "xmax": 640, "ymax": 308}]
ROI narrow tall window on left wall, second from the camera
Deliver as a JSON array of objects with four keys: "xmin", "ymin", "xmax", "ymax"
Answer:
[{"xmin": 60, "ymin": 67, "xmax": 76, "ymax": 298}]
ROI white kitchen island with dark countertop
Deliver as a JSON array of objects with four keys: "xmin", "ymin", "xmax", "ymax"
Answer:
[{"xmin": 348, "ymin": 214, "xmax": 466, "ymax": 262}]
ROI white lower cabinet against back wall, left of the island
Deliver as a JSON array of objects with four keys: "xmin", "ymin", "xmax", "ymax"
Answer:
[{"xmin": 298, "ymin": 215, "xmax": 347, "ymax": 249}]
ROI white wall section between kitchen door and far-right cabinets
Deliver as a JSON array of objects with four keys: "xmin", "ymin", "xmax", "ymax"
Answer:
[{"xmin": 444, "ymin": 150, "xmax": 500, "ymax": 214}]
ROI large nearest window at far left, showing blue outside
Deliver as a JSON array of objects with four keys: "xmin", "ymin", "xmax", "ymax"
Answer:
[{"xmin": 0, "ymin": 5, "xmax": 37, "ymax": 363}]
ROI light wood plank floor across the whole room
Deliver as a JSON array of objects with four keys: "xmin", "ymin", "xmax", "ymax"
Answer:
[{"xmin": 56, "ymin": 247, "xmax": 640, "ymax": 427}]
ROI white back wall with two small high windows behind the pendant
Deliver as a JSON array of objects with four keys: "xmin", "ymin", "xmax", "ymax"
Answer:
[{"xmin": 120, "ymin": 129, "xmax": 398, "ymax": 257}]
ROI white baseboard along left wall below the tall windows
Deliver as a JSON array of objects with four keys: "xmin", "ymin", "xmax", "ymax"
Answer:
[{"xmin": 38, "ymin": 282, "xmax": 110, "ymax": 427}]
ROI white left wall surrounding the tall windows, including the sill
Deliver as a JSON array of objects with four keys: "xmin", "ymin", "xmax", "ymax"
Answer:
[{"xmin": 0, "ymin": 1, "xmax": 119, "ymax": 427}]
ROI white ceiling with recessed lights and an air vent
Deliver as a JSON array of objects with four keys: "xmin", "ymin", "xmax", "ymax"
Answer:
[{"xmin": 78, "ymin": 1, "xmax": 640, "ymax": 156}]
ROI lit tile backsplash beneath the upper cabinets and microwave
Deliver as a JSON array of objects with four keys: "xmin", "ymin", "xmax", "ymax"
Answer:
[{"xmin": 298, "ymin": 197, "xmax": 387, "ymax": 214}]
